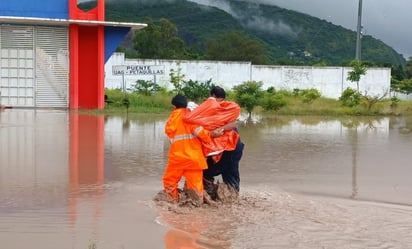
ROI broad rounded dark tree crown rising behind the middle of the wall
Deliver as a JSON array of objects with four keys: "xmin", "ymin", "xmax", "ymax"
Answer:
[{"xmin": 205, "ymin": 32, "xmax": 268, "ymax": 65}]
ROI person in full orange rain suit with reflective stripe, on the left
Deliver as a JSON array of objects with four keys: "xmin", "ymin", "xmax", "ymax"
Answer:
[{"xmin": 163, "ymin": 95, "xmax": 223, "ymax": 201}]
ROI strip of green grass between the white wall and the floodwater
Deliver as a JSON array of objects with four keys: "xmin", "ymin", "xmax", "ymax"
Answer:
[{"xmin": 101, "ymin": 89, "xmax": 412, "ymax": 116}]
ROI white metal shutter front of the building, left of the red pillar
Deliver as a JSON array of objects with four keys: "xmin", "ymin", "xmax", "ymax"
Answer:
[{"xmin": 0, "ymin": 24, "xmax": 69, "ymax": 108}]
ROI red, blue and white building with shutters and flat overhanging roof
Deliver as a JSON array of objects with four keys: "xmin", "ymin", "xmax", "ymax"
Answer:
[{"xmin": 0, "ymin": 0, "xmax": 146, "ymax": 109}]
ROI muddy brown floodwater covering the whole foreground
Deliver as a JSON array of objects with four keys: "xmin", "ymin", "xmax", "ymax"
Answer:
[{"xmin": 0, "ymin": 109, "xmax": 412, "ymax": 249}]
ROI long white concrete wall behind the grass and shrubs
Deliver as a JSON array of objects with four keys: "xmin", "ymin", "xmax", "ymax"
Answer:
[{"xmin": 105, "ymin": 53, "xmax": 391, "ymax": 99}]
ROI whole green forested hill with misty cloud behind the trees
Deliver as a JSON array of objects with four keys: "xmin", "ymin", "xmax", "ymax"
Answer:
[{"xmin": 94, "ymin": 0, "xmax": 405, "ymax": 66}]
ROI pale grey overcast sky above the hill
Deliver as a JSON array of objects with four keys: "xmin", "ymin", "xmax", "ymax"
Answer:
[{"xmin": 189, "ymin": 0, "xmax": 412, "ymax": 59}]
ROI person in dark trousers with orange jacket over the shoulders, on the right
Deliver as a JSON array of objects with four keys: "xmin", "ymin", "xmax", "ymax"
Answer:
[{"xmin": 183, "ymin": 86, "xmax": 244, "ymax": 200}]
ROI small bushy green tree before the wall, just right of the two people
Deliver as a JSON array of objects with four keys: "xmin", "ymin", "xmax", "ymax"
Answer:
[{"xmin": 233, "ymin": 81, "xmax": 263, "ymax": 117}]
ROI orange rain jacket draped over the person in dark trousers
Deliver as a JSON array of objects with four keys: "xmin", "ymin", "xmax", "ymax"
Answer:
[{"xmin": 183, "ymin": 97, "xmax": 240, "ymax": 161}]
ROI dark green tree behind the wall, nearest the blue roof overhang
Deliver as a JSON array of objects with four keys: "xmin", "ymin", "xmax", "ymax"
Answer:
[{"xmin": 134, "ymin": 17, "xmax": 187, "ymax": 59}]
